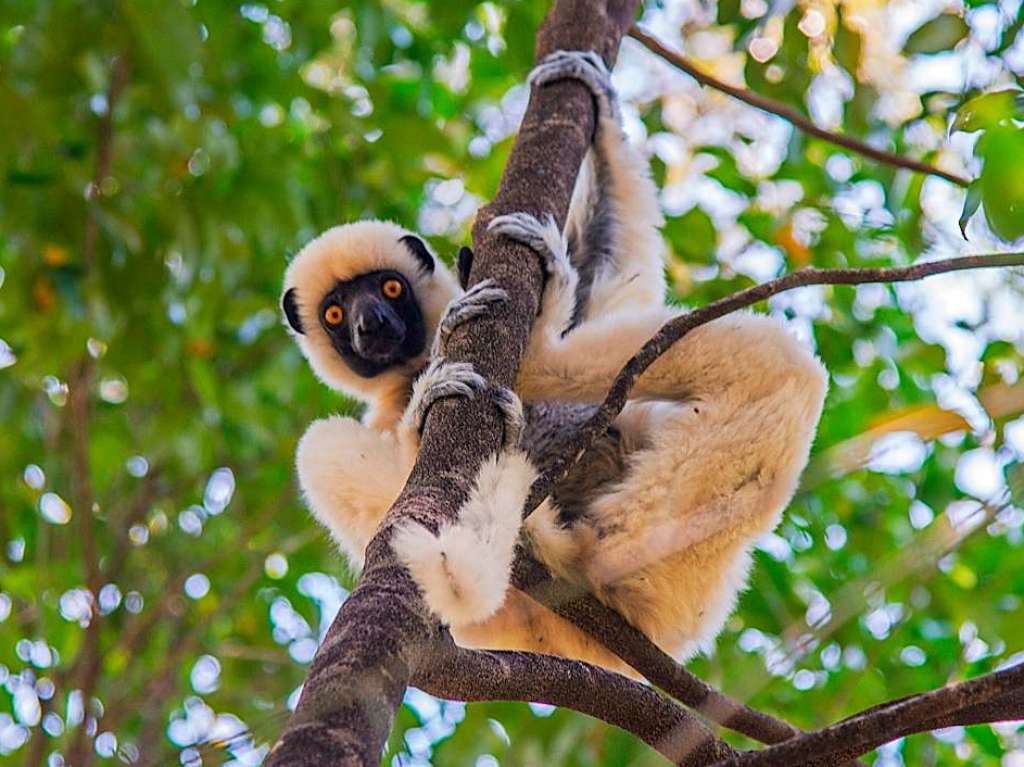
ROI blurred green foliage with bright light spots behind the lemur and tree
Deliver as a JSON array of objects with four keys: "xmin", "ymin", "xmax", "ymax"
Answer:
[{"xmin": 0, "ymin": 0, "xmax": 1024, "ymax": 767}]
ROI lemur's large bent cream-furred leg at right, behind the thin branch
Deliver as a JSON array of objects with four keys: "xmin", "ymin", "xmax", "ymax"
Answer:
[{"xmin": 527, "ymin": 314, "xmax": 826, "ymax": 654}]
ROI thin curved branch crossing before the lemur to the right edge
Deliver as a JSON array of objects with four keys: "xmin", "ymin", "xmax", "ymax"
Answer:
[{"xmin": 525, "ymin": 253, "xmax": 1024, "ymax": 516}]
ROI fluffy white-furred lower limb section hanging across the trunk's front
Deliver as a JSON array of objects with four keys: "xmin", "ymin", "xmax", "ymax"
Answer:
[{"xmin": 391, "ymin": 451, "xmax": 537, "ymax": 626}]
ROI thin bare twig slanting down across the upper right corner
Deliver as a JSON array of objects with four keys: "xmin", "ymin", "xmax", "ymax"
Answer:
[{"xmin": 630, "ymin": 26, "xmax": 971, "ymax": 186}]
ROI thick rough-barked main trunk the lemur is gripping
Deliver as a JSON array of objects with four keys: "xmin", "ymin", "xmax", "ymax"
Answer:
[{"xmin": 268, "ymin": 0, "xmax": 638, "ymax": 767}]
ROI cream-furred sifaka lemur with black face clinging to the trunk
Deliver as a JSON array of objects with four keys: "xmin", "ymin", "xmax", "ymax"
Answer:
[{"xmin": 283, "ymin": 51, "xmax": 827, "ymax": 668}]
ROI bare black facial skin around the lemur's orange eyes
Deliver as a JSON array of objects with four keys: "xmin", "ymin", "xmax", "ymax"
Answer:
[{"xmin": 313, "ymin": 270, "xmax": 426, "ymax": 378}]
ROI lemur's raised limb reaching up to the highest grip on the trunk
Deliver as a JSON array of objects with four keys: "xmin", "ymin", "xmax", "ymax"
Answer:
[{"xmin": 529, "ymin": 51, "xmax": 665, "ymax": 323}]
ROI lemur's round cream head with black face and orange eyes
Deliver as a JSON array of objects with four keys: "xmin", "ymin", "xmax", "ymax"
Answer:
[{"xmin": 281, "ymin": 221, "xmax": 458, "ymax": 397}]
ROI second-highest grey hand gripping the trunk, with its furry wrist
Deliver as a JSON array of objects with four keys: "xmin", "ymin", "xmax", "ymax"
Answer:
[{"xmin": 487, "ymin": 213, "xmax": 580, "ymax": 333}]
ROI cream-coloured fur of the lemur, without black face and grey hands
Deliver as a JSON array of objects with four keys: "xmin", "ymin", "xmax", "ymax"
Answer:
[{"xmin": 286, "ymin": 52, "xmax": 826, "ymax": 671}]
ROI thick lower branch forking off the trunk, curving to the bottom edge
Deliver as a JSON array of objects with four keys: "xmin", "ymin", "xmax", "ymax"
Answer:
[{"xmin": 414, "ymin": 632, "xmax": 736, "ymax": 767}]
